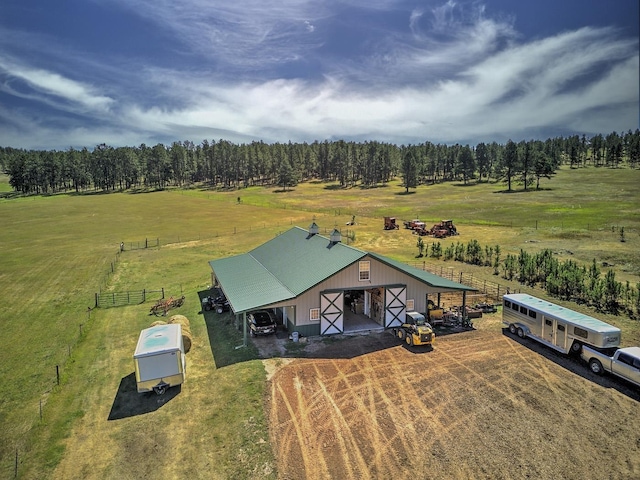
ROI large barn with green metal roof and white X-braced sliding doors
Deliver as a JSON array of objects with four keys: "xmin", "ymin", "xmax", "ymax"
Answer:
[{"xmin": 209, "ymin": 222, "xmax": 474, "ymax": 336}]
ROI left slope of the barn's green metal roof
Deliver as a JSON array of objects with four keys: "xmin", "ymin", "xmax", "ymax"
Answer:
[{"xmin": 209, "ymin": 227, "xmax": 367, "ymax": 313}]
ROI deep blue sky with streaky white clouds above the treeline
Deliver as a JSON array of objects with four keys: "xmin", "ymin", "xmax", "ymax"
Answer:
[{"xmin": 0, "ymin": 0, "xmax": 640, "ymax": 149}]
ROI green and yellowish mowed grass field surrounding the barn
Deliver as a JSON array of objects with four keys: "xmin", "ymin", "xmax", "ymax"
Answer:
[{"xmin": 0, "ymin": 164, "xmax": 640, "ymax": 478}]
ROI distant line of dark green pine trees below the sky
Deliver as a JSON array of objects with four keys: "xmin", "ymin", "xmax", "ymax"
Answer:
[{"xmin": 0, "ymin": 130, "xmax": 640, "ymax": 194}]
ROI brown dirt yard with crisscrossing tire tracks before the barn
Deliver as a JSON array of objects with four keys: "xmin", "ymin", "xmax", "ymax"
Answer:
[{"xmin": 267, "ymin": 315, "xmax": 640, "ymax": 480}]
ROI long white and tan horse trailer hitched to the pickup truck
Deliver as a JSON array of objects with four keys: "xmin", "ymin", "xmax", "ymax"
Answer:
[{"xmin": 502, "ymin": 293, "xmax": 620, "ymax": 353}]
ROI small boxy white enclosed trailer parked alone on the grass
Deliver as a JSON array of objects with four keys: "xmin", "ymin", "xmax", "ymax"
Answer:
[{"xmin": 133, "ymin": 324, "xmax": 187, "ymax": 395}]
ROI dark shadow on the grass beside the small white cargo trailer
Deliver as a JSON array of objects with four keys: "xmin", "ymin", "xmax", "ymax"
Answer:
[{"xmin": 107, "ymin": 372, "xmax": 182, "ymax": 420}]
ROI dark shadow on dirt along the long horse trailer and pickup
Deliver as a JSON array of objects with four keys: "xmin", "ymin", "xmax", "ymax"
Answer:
[{"xmin": 502, "ymin": 328, "xmax": 640, "ymax": 402}]
